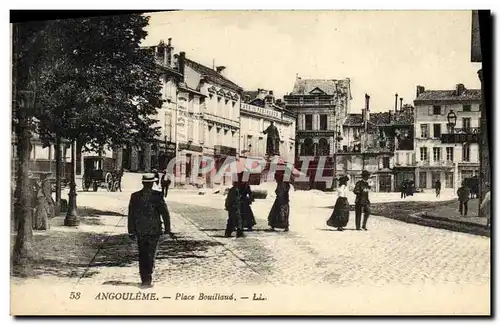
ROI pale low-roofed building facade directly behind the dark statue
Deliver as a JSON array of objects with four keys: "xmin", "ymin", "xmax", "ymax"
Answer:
[{"xmin": 240, "ymin": 89, "xmax": 296, "ymax": 163}]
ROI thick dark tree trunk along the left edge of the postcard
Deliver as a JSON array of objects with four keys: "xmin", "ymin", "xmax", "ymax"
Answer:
[{"xmin": 12, "ymin": 24, "xmax": 33, "ymax": 265}]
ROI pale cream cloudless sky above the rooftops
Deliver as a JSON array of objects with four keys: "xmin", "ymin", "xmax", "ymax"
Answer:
[{"xmin": 143, "ymin": 11, "xmax": 481, "ymax": 112}]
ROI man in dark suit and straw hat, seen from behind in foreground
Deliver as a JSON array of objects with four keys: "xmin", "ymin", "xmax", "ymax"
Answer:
[{"xmin": 128, "ymin": 174, "xmax": 170, "ymax": 287}]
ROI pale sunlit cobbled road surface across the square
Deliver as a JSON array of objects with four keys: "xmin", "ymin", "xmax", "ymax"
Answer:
[{"xmin": 72, "ymin": 189, "xmax": 490, "ymax": 286}]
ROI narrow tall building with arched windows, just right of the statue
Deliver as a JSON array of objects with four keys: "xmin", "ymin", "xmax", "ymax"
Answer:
[{"xmin": 284, "ymin": 77, "xmax": 352, "ymax": 190}]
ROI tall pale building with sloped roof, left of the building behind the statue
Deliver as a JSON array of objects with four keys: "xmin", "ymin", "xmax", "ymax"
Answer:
[{"xmin": 184, "ymin": 59, "xmax": 243, "ymax": 187}]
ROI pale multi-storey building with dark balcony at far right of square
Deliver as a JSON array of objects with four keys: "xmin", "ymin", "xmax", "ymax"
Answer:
[{"xmin": 414, "ymin": 84, "xmax": 481, "ymax": 190}]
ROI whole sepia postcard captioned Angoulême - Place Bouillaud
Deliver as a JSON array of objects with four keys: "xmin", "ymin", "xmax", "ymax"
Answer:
[{"xmin": 10, "ymin": 10, "xmax": 492, "ymax": 316}]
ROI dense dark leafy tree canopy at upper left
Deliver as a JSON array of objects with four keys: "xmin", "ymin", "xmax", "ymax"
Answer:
[{"xmin": 34, "ymin": 14, "xmax": 163, "ymax": 150}]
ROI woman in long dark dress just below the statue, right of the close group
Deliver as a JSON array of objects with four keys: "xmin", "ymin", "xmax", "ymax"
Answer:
[{"xmin": 267, "ymin": 173, "xmax": 290, "ymax": 231}]
